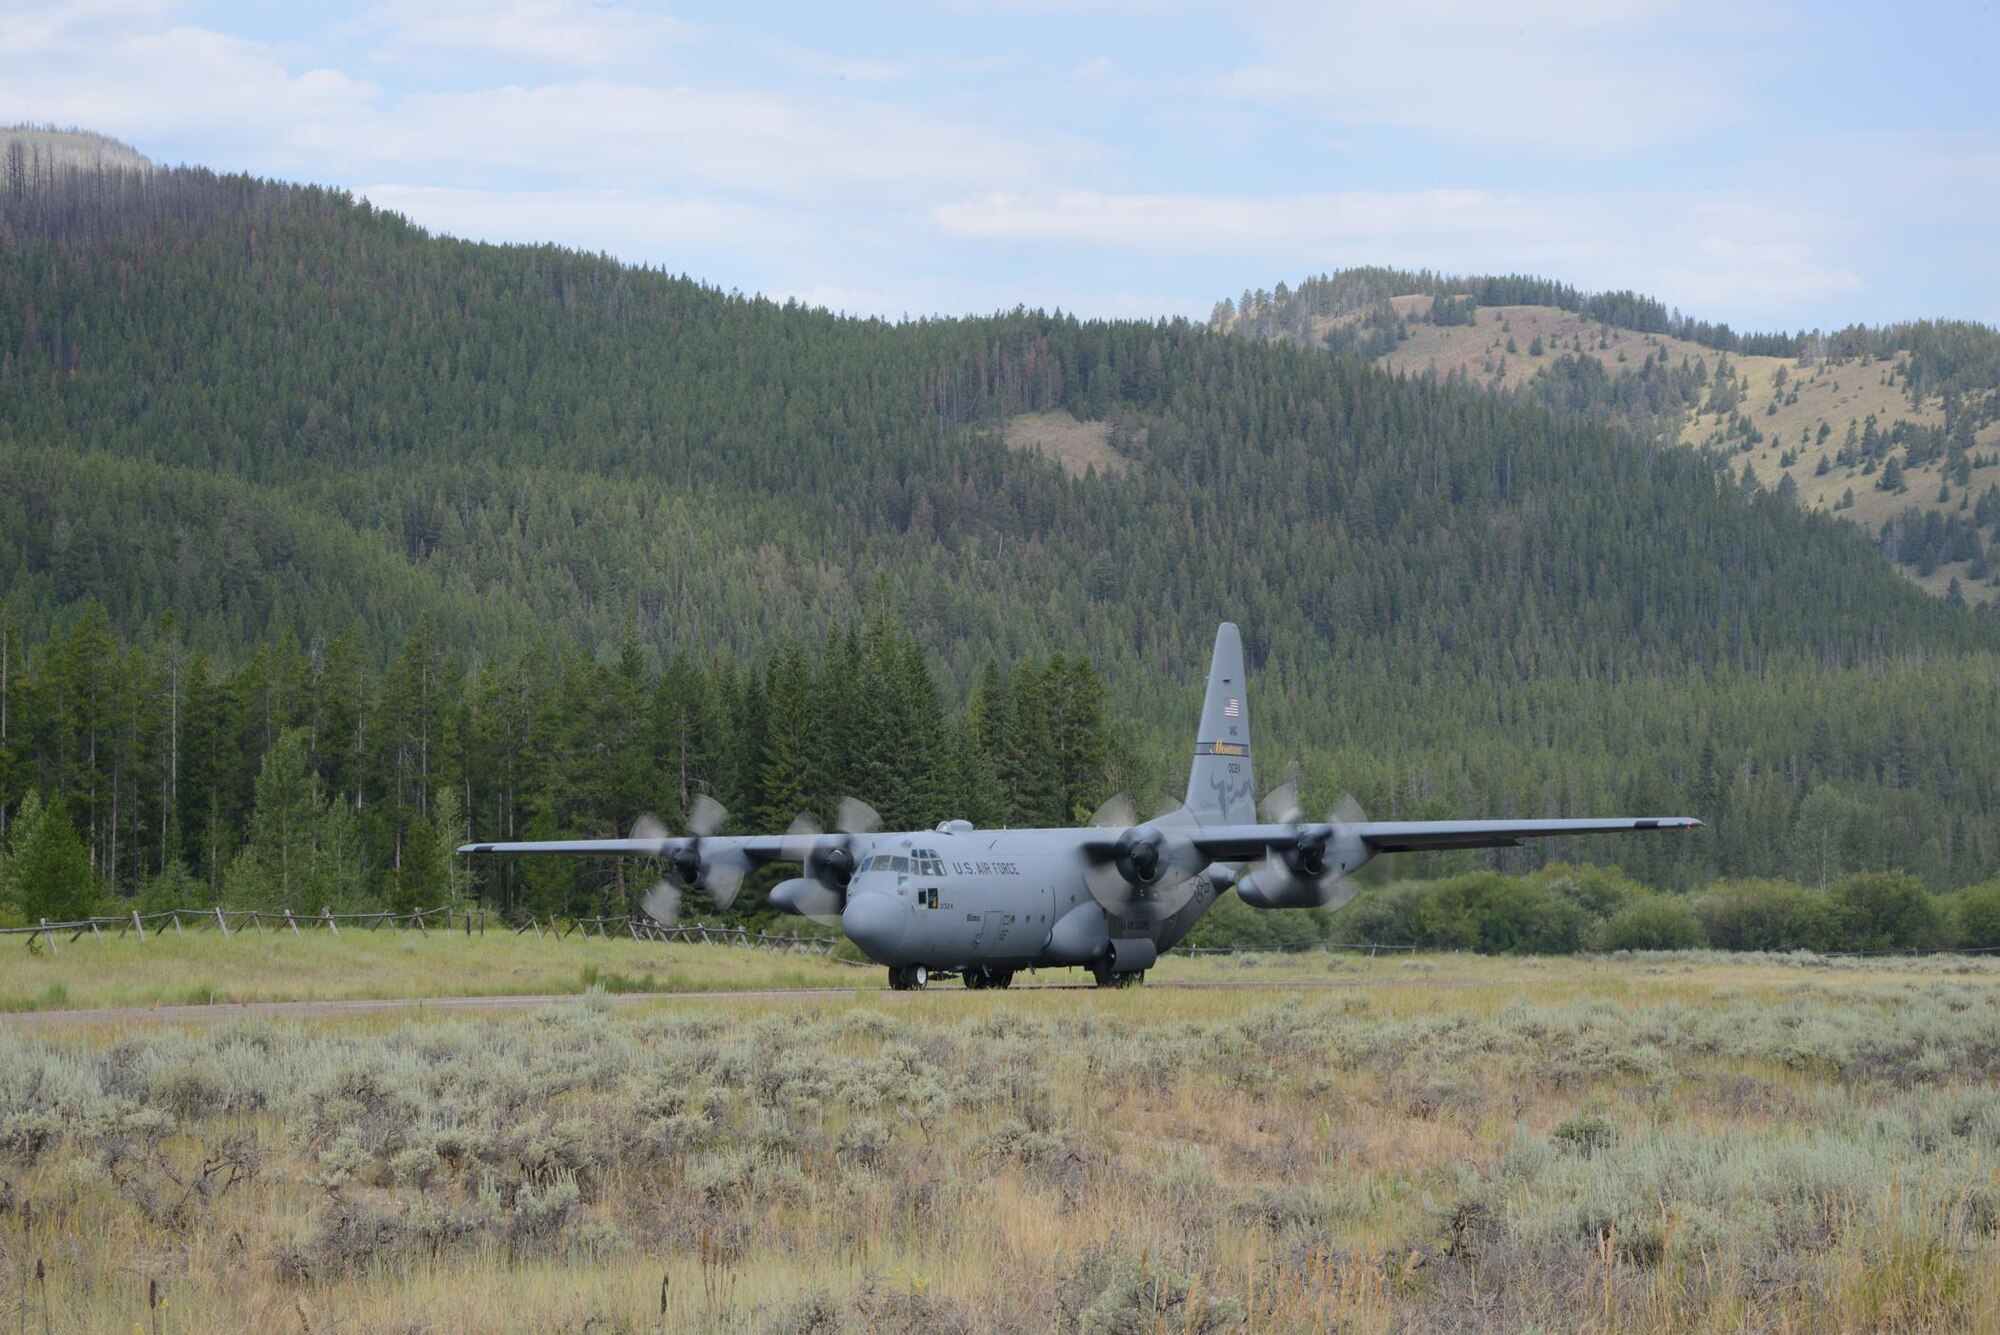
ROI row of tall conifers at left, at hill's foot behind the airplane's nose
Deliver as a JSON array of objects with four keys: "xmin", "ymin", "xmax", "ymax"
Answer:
[{"xmin": 0, "ymin": 604, "xmax": 1118, "ymax": 921}]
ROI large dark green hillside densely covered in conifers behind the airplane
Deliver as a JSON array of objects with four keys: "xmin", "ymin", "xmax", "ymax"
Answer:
[{"xmin": 0, "ymin": 153, "xmax": 2000, "ymax": 907}]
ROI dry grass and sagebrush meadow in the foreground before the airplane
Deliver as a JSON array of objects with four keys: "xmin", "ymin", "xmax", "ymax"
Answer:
[{"xmin": 0, "ymin": 937, "xmax": 2000, "ymax": 1333}]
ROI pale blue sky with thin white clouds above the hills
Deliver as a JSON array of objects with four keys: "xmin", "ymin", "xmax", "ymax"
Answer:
[{"xmin": 0, "ymin": 0, "xmax": 2000, "ymax": 330}]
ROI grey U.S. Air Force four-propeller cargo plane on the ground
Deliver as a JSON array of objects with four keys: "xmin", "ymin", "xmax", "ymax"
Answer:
[{"xmin": 458, "ymin": 622, "xmax": 1702, "ymax": 989}]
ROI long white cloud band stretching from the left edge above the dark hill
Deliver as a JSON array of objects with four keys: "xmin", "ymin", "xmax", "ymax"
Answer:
[{"xmin": 0, "ymin": 6, "xmax": 1084, "ymax": 208}]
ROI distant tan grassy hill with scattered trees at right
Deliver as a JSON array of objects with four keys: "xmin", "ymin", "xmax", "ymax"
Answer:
[{"xmin": 1210, "ymin": 270, "xmax": 2000, "ymax": 602}]
